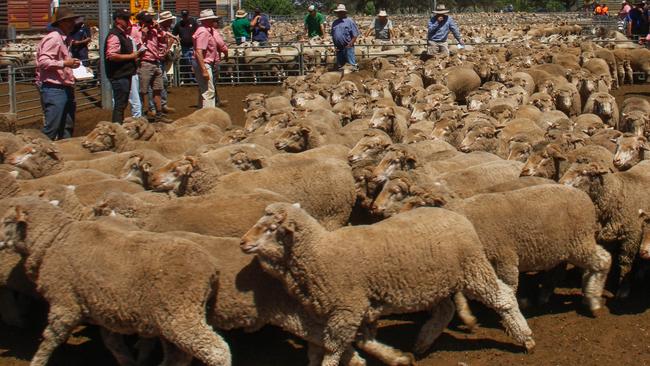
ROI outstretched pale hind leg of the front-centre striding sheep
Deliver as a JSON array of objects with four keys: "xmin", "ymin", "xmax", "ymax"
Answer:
[{"xmin": 463, "ymin": 264, "xmax": 535, "ymax": 351}]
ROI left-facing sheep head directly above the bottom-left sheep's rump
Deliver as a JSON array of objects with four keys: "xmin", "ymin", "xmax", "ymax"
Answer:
[{"xmin": 150, "ymin": 156, "xmax": 199, "ymax": 193}]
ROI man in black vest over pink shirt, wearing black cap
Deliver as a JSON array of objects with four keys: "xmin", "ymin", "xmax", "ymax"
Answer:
[{"xmin": 104, "ymin": 9, "xmax": 142, "ymax": 123}]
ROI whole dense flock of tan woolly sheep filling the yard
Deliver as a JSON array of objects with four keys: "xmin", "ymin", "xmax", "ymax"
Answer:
[{"xmin": 0, "ymin": 10, "xmax": 650, "ymax": 366}]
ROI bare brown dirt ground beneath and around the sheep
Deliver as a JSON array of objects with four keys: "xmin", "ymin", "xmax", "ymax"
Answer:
[{"xmin": 0, "ymin": 85, "xmax": 650, "ymax": 366}]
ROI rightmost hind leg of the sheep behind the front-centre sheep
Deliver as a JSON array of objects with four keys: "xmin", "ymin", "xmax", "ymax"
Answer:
[{"xmin": 571, "ymin": 243, "xmax": 612, "ymax": 315}]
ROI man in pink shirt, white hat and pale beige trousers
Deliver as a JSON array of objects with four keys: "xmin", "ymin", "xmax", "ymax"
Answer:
[{"xmin": 192, "ymin": 9, "xmax": 228, "ymax": 108}]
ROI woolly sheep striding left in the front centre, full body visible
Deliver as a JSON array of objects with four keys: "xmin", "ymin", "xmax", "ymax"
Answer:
[{"xmin": 241, "ymin": 203, "xmax": 535, "ymax": 366}]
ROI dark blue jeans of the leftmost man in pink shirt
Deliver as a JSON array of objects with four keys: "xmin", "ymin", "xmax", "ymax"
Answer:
[{"xmin": 40, "ymin": 84, "xmax": 77, "ymax": 140}]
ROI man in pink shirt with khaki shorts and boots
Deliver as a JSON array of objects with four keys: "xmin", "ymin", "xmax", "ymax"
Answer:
[{"xmin": 138, "ymin": 14, "xmax": 172, "ymax": 123}]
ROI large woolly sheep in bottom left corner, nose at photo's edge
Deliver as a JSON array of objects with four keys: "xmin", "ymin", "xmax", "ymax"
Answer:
[{"xmin": 2, "ymin": 197, "xmax": 231, "ymax": 366}]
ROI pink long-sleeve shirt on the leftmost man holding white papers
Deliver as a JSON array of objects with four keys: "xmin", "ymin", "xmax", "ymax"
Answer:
[{"xmin": 36, "ymin": 29, "xmax": 74, "ymax": 86}]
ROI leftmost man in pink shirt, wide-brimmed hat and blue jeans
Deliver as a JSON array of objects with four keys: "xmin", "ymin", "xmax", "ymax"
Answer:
[{"xmin": 36, "ymin": 7, "xmax": 80, "ymax": 140}]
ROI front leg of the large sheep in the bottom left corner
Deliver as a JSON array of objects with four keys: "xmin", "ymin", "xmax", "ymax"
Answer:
[{"xmin": 30, "ymin": 302, "xmax": 81, "ymax": 366}]
